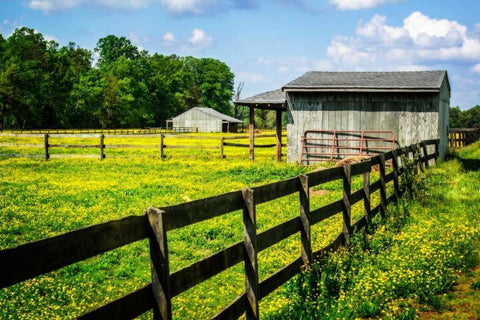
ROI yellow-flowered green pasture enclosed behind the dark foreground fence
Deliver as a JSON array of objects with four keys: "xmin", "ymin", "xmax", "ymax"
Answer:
[{"xmin": 0, "ymin": 134, "xmax": 384, "ymax": 319}]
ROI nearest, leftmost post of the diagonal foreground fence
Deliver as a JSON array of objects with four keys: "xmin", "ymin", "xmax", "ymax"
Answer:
[{"xmin": 147, "ymin": 208, "xmax": 172, "ymax": 320}]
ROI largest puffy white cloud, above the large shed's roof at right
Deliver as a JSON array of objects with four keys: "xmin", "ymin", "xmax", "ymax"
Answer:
[{"xmin": 327, "ymin": 11, "xmax": 480, "ymax": 69}]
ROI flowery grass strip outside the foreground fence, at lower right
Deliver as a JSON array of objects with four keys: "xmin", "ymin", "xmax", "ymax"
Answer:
[{"xmin": 267, "ymin": 146, "xmax": 480, "ymax": 319}]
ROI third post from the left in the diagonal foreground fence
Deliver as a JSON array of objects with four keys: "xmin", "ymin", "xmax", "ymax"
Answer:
[{"xmin": 298, "ymin": 174, "xmax": 313, "ymax": 264}]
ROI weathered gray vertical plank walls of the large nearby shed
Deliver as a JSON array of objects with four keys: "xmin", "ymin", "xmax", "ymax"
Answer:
[{"xmin": 287, "ymin": 92, "xmax": 448, "ymax": 162}]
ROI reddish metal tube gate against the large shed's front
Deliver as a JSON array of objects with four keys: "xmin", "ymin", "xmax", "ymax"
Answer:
[{"xmin": 300, "ymin": 130, "xmax": 395, "ymax": 164}]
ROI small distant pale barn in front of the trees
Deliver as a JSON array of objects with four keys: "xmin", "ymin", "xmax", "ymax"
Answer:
[{"xmin": 171, "ymin": 107, "xmax": 243, "ymax": 132}]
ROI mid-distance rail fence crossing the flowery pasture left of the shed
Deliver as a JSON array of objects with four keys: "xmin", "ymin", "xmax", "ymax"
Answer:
[{"xmin": 0, "ymin": 133, "xmax": 285, "ymax": 160}]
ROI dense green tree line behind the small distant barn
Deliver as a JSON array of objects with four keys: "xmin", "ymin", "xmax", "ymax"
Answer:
[{"xmin": 0, "ymin": 27, "xmax": 234, "ymax": 129}]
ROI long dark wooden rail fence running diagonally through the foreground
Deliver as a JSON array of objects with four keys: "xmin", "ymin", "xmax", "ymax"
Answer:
[{"xmin": 0, "ymin": 140, "xmax": 439, "ymax": 319}]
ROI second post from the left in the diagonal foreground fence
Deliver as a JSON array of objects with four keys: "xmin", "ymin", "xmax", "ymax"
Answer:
[{"xmin": 242, "ymin": 188, "xmax": 259, "ymax": 320}]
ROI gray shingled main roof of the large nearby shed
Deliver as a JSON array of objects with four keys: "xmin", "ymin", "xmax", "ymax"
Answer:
[{"xmin": 282, "ymin": 70, "xmax": 450, "ymax": 92}]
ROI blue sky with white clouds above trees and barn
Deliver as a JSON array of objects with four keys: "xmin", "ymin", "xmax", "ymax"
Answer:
[{"xmin": 0, "ymin": 0, "xmax": 480, "ymax": 109}]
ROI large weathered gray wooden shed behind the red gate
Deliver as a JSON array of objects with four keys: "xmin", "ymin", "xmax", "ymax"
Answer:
[{"xmin": 282, "ymin": 71, "xmax": 450, "ymax": 162}]
